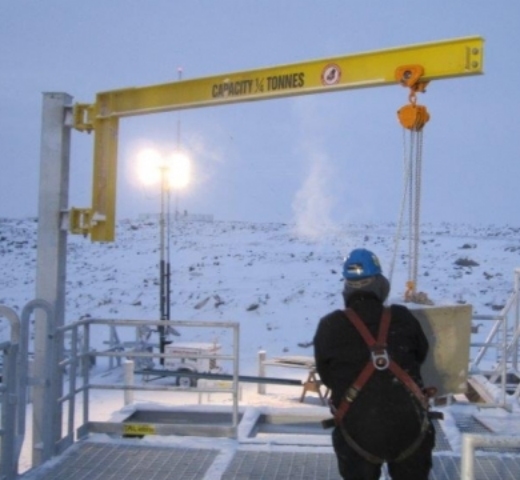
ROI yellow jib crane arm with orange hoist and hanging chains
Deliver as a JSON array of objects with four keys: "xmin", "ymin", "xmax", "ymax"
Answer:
[{"xmin": 69, "ymin": 36, "xmax": 484, "ymax": 295}]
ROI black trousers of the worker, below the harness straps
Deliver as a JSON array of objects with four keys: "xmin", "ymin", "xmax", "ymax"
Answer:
[{"xmin": 332, "ymin": 425, "xmax": 435, "ymax": 480}]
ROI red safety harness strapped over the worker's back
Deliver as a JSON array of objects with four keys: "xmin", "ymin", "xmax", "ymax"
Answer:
[{"xmin": 322, "ymin": 308, "xmax": 430, "ymax": 463}]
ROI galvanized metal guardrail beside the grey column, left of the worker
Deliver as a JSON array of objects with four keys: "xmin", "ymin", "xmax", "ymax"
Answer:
[{"xmin": 50, "ymin": 319, "xmax": 240, "ymax": 448}]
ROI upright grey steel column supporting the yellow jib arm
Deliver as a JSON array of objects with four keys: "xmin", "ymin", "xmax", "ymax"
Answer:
[{"xmin": 32, "ymin": 93, "xmax": 72, "ymax": 466}]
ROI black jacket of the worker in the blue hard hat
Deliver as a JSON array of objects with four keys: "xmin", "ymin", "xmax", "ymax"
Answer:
[{"xmin": 314, "ymin": 295, "xmax": 428, "ymax": 457}]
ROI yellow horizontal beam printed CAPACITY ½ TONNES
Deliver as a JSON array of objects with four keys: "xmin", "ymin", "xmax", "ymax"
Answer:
[{"xmin": 95, "ymin": 37, "xmax": 484, "ymax": 118}]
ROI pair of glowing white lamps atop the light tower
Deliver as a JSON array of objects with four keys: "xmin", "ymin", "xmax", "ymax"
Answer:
[{"xmin": 137, "ymin": 148, "xmax": 191, "ymax": 190}]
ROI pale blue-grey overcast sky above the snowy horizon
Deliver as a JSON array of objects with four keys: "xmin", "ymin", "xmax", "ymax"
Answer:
[{"xmin": 0, "ymin": 0, "xmax": 520, "ymax": 231}]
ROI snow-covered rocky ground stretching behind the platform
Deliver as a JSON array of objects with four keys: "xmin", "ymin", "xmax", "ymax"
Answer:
[{"xmin": 0, "ymin": 216, "xmax": 520, "ymax": 471}]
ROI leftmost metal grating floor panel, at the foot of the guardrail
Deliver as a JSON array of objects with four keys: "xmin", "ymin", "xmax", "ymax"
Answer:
[{"xmin": 21, "ymin": 442, "xmax": 219, "ymax": 480}]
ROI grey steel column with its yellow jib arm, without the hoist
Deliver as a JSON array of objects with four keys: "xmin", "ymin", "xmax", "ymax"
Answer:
[{"xmin": 33, "ymin": 37, "xmax": 484, "ymax": 466}]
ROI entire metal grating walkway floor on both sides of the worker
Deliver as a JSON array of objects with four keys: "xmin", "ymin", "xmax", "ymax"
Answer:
[{"xmin": 21, "ymin": 440, "xmax": 520, "ymax": 480}]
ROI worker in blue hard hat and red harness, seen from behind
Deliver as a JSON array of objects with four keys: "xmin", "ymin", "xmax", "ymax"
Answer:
[{"xmin": 314, "ymin": 248, "xmax": 435, "ymax": 480}]
